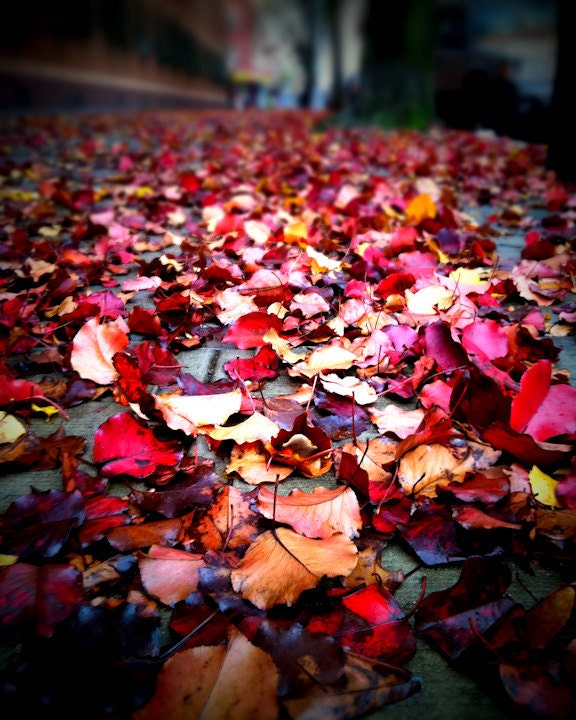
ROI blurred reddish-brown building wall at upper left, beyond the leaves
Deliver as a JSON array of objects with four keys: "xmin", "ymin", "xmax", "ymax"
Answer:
[{"xmin": 0, "ymin": 0, "xmax": 230, "ymax": 112}]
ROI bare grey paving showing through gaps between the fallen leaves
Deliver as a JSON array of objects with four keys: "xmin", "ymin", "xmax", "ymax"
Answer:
[{"xmin": 0, "ymin": 109, "xmax": 576, "ymax": 720}]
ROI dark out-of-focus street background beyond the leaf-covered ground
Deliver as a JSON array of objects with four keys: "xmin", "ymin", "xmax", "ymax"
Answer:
[{"xmin": 0, "ymin": 0, "xmax": 561, "ymax": 142}]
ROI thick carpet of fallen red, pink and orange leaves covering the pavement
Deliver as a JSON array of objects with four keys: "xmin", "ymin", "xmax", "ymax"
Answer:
[{"xmin": 0, "ymin": 112, "xmax": 576, "ymax": 720}]
